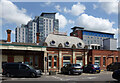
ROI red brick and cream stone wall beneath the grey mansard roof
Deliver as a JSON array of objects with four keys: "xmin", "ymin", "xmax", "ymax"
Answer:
[{"xmin": 47, "ymin": 47, "xmax": 87, "ymax": 72}]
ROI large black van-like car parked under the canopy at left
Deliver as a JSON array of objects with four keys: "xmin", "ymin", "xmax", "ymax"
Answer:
[{"xmin": 2, "ymin": 63, "xmax": 41, "ymax": 77}]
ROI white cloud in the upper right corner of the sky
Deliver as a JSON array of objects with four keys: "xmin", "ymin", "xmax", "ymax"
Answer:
[{"xmin": 100, "ymin": 0, "xmax": 118, "ymax": 14}]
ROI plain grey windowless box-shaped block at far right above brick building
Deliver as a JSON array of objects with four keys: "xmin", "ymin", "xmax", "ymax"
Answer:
[{"xmin": 103, "ymin": 38, "xmax": 117, "ymax": 50}]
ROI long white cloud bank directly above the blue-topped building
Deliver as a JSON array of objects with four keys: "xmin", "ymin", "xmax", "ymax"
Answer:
[{"xmin": 76, "ymin": 14, "xmax": 116, "ymax": 32}]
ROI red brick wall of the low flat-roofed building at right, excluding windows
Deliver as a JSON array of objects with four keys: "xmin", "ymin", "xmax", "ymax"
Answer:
[{"xmin": 88, "ymin": 50, "xmax": 118, "ymax": 69}]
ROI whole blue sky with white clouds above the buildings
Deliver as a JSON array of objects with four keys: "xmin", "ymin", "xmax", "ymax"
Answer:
[{"xmin": 0, "ymin": 0, "xmax": 118, "ymax": 46}]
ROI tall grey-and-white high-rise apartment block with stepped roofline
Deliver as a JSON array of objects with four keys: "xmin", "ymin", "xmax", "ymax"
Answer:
[{"xmin": 15, "ymin": 13, "xmax": 59, "ymax": 43}]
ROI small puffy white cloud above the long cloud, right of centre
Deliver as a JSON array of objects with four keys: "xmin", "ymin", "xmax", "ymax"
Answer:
[{"xmin": 64, "ymin": 3, "xmax": 86, "ymax": 16}]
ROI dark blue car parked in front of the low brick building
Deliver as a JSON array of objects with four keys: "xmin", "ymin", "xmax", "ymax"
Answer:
[{"xmin": 83, "ymin": 64, "xmax": 100, "ymax": 73}]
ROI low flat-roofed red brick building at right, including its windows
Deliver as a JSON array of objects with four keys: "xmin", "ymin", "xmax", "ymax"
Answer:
[{"xmin": 87, "ymin": 50, "xmax": 119, "ymax": 69}]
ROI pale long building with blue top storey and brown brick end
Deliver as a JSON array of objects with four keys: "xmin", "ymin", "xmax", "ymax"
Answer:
[{"xmin": 70, "ymin": 27, "xmax": 114, "ymax": 49}]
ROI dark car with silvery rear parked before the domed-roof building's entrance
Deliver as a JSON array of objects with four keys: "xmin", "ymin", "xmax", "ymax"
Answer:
[{"xmin": 61, "ymin": 64, "xmax": 83, "ymax": 75}]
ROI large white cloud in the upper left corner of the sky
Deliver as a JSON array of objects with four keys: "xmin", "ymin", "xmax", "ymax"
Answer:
[{"xmin": 0, "ymin": 0, "xmax": 31, "ymax": 25}]
